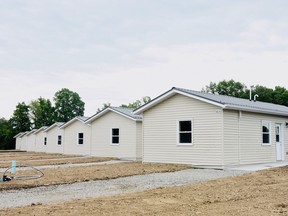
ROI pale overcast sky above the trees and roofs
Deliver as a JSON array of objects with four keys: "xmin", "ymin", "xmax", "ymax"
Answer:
[{"xmin": 0, "ymin": 0, "xmax": 288, "ymax": 119}]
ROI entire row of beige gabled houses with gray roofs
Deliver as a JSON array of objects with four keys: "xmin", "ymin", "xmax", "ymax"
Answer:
[{"xmin": 15, "ymin": 87, "xmax": 288, "ymax": 167}]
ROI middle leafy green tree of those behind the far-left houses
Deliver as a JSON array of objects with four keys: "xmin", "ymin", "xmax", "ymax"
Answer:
[{"xmin": 30, "ymin": 97, "xmax": 55, "ymax": 128}]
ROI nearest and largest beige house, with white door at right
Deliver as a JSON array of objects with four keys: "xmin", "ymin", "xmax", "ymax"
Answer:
[{"xmin": 134, "ymin": 88, "xmax": 288, "ymax": 167}]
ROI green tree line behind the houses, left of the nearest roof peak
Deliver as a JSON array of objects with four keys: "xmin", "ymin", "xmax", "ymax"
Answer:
[{"xmin": 0, "ymin": 88, "xmax": 151, "ymax": 149}]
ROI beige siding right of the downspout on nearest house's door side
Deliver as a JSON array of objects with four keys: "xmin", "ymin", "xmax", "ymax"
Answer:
[{"xmin": 239, "ymin": 112, "xmax": 288, "ymax": 164}]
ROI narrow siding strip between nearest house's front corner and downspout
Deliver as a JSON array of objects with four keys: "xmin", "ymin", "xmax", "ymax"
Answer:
[{"xmin": 223, "ymin": 110, "xmax": 241, "ymax": 165}]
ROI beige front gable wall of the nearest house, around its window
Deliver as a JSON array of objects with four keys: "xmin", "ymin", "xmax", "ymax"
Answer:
[{"xmin": 143, "ymin": 94, "xmax": 223, "ymax": 166}]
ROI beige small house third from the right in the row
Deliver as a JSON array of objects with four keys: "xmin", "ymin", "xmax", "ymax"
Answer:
[{"xmin": 60, "ymin": 116, "xmax": 91, "ymax": 155}]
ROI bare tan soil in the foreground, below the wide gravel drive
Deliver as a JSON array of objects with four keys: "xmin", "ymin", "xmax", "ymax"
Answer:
[{"xmin": 0, "ymin": 167, "xmax": 288, "ymax": 216}]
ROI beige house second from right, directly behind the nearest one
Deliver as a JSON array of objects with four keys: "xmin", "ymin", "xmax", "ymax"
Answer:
[{"xmin": 86, "ymin": 107, "xmax": 142, "ymax": 160}]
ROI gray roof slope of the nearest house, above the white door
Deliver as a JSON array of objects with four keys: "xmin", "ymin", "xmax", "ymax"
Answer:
[{"xmin": 173, "ymin": 88, "xmax": 288, "ymax": 116}]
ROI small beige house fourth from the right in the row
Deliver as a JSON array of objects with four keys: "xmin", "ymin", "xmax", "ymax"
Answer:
[{"xmin": 45, "ymin": 122, "xmax": 64, "ymax": 154}]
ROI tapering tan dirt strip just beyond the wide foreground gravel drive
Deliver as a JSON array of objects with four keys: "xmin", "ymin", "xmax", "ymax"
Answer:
[{"xmin": 0, "ymin": 162, "xmax": 191, "ymax": 191}]
